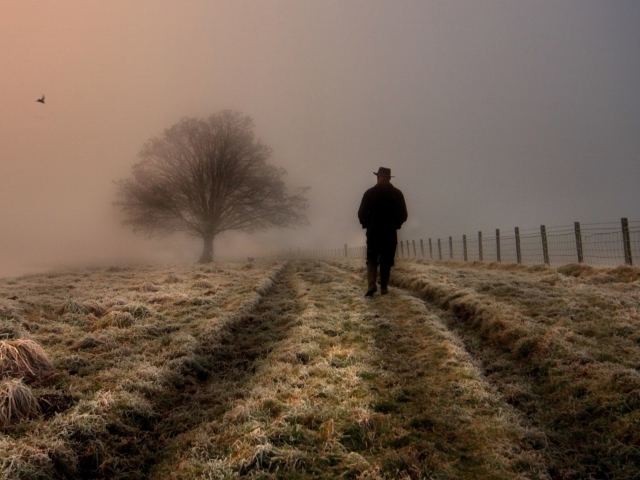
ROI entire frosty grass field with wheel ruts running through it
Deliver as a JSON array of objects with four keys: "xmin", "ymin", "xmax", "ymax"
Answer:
[{"xmin": 0, "ymin": 259, "xmax": 640, "ymax": 479}]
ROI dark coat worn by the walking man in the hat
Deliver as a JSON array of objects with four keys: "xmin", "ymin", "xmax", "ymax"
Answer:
[{"xmin": 358, "ymin": 183, "xmax": 407, "ymax": 233}]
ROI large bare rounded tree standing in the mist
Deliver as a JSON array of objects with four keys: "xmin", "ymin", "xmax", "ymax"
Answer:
[{"xmin": 115, "ymin": 110, "xmax": 308, "ymax": 262}]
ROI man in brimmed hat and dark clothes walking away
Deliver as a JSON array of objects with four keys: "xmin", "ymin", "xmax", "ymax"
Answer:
[{"xmin": 358, "ymin": 167, "xmax": 407, "ymax": 297}]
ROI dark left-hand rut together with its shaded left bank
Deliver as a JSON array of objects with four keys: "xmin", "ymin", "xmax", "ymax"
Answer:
[{"xmin": 25, "ymin": 264, "xmax": 299, "ymax": 479}]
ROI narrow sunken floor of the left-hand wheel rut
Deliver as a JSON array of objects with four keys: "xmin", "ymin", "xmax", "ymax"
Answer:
[{"xmin": 148, "ymin": 265, "xmax": 300, "ymax": 478}]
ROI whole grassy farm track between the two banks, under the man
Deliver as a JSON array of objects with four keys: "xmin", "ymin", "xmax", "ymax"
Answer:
[{"xmin": 158, "ymin": 261, "xmax": 548, "ymax": 479}]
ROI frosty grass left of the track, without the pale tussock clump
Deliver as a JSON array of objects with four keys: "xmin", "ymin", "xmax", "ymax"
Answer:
[{"xmin": 0, "ymin": 263, "xmax": 283, "ymax": 478}]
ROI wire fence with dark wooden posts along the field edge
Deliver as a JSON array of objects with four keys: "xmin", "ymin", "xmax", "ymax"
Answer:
[{"xmin": 295, "ymin": 218, "xmax": 640, "ymax": 267}]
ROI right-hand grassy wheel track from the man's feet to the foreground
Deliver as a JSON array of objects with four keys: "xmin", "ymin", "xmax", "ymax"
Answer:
[{"xmin": 318, "ymin": 264, "xmax": 549, "ymax": 478}]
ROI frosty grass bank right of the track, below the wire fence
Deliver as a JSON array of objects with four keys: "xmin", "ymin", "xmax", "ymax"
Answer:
[{"xmin": 332, "ymin": 261, "xmax": 640, "ymax": 479}]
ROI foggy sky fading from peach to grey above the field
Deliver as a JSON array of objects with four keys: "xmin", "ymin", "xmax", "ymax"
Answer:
[{"xmin": 0, "ymin": 0, "xmax": 640, "ymax": 276}]
